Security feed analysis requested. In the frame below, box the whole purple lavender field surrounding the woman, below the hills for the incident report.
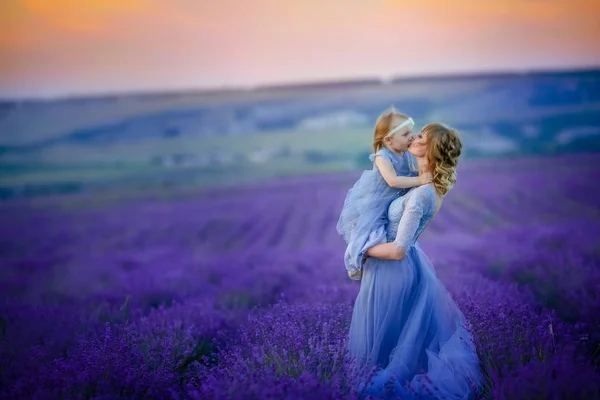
[0,154,600,399]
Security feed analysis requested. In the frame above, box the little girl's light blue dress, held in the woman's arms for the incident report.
[337,147,418,280]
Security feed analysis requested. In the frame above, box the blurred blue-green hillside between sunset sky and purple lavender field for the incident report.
[0,72,600,202]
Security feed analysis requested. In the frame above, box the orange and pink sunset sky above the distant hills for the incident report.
[0,0,600,97]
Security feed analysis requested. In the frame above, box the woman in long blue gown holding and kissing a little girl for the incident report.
[349,124,481,399]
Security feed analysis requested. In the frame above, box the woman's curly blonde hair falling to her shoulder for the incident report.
[421,123,462,196]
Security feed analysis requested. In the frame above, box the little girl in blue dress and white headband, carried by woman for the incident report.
[337,109,432,280]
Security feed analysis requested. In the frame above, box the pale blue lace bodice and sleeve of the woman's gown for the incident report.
[387,185,435,247]
